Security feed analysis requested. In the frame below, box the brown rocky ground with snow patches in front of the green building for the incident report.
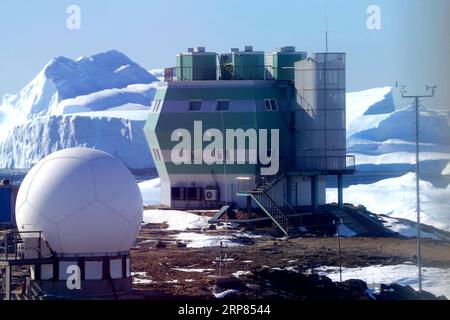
[132,225,450,299]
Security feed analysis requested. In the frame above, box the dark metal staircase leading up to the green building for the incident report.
[240,172,301,236]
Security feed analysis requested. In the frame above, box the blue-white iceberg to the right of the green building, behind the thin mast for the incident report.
[347,87,450,173]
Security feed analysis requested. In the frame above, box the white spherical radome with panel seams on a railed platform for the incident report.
[16,148,143,254]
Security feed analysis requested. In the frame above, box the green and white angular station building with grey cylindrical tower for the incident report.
[145,46,354,234]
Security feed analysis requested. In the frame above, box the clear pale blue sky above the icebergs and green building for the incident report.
[0,0,450,109]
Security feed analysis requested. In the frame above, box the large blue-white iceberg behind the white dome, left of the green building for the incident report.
[0,50,158,169]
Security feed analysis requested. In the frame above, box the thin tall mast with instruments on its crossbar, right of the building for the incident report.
[395,83,437,292]
